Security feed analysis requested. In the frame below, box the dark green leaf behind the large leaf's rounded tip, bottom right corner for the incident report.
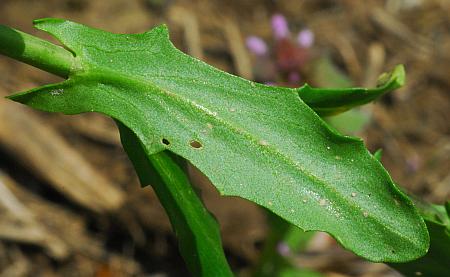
[390,200,450,277]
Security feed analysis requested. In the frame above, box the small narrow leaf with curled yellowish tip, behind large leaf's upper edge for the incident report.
[297,65,405,116]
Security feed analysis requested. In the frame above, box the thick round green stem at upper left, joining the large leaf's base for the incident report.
[0,25,75,78]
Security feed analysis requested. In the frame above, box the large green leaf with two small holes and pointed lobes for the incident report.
[7,19,429,262]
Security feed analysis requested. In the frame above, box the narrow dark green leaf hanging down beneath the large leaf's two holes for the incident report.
[117,122,233,276]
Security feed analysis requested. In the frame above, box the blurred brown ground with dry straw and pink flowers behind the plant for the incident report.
[0,0,450,277]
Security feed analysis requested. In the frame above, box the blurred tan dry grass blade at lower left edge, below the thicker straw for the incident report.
[0,172,105,260]
